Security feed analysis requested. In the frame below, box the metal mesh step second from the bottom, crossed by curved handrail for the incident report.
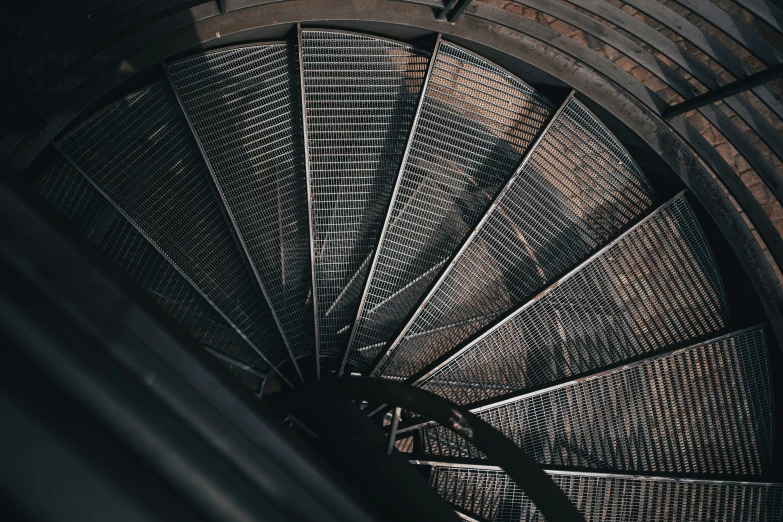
[422,329,772,475]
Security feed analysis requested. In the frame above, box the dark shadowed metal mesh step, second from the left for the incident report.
[60,83,289,365]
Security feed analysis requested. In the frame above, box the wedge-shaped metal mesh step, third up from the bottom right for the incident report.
[420,196,728,404]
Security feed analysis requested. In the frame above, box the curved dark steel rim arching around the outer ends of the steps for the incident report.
[0,0,783,358]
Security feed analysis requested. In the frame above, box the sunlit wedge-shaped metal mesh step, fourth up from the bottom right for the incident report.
[379,99,653,377]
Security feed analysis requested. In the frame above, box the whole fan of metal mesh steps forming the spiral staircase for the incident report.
[4,2,783,521]
